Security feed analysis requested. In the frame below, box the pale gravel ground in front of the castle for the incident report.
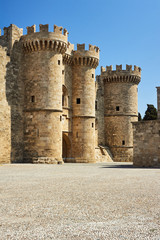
[0,163,160,240]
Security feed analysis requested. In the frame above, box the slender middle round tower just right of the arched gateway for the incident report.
[72,44,99,162]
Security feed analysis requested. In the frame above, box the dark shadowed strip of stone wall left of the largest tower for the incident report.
[6,41,24,162]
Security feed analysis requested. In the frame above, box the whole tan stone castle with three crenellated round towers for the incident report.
[0,24,159,166]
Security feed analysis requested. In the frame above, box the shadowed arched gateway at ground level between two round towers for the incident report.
[62,133,71,162]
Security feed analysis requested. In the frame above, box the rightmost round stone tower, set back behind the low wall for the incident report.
[101,65,141,162]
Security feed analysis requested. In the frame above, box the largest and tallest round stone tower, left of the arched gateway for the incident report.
[21,24,67,163]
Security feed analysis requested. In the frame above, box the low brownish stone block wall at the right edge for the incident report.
[133,120,160,167]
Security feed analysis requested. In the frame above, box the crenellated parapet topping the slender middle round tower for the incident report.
[73,44,99,68]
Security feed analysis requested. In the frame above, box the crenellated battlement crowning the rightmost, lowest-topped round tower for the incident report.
[101,64,141,84]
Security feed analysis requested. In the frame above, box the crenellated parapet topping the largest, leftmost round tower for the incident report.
[21,24,68,53]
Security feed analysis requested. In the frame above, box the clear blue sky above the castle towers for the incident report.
[0,0,160,116]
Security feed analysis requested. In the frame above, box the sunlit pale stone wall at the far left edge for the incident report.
[0,46,11,163]
